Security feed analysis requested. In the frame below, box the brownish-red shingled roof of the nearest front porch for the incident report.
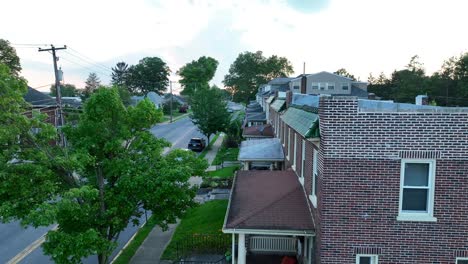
[224,171,315,233]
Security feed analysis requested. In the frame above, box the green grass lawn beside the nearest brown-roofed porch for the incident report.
[161,200,229,260]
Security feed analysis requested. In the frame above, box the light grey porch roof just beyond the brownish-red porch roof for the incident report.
[238,138,284,161]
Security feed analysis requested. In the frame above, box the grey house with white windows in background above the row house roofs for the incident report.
[289,71,368,99]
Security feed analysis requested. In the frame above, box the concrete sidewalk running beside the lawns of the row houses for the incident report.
[130,133,224,264]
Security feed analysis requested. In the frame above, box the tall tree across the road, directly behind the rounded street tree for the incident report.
[177,56,218,97]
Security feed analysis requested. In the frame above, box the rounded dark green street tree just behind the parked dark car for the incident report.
[190,87,230,142]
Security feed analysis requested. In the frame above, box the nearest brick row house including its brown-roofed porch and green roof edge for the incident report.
[223,89,468,264]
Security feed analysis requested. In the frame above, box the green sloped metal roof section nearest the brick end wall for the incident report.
[281,107,320,138]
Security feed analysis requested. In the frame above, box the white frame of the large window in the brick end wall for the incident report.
[397,159,437,222]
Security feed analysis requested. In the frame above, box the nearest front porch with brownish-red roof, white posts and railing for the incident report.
[223,171,315,264]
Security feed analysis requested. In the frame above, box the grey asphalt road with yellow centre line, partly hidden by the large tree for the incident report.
[0,117,203,264]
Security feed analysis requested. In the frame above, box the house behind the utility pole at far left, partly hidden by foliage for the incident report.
[23,87,59,126]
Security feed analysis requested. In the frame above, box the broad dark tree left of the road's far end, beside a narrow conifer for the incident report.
[126,57,171,95]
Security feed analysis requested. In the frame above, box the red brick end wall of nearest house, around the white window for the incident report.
[316,97,468,264]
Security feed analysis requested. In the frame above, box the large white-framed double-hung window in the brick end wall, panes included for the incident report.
[397,159,437,221]
